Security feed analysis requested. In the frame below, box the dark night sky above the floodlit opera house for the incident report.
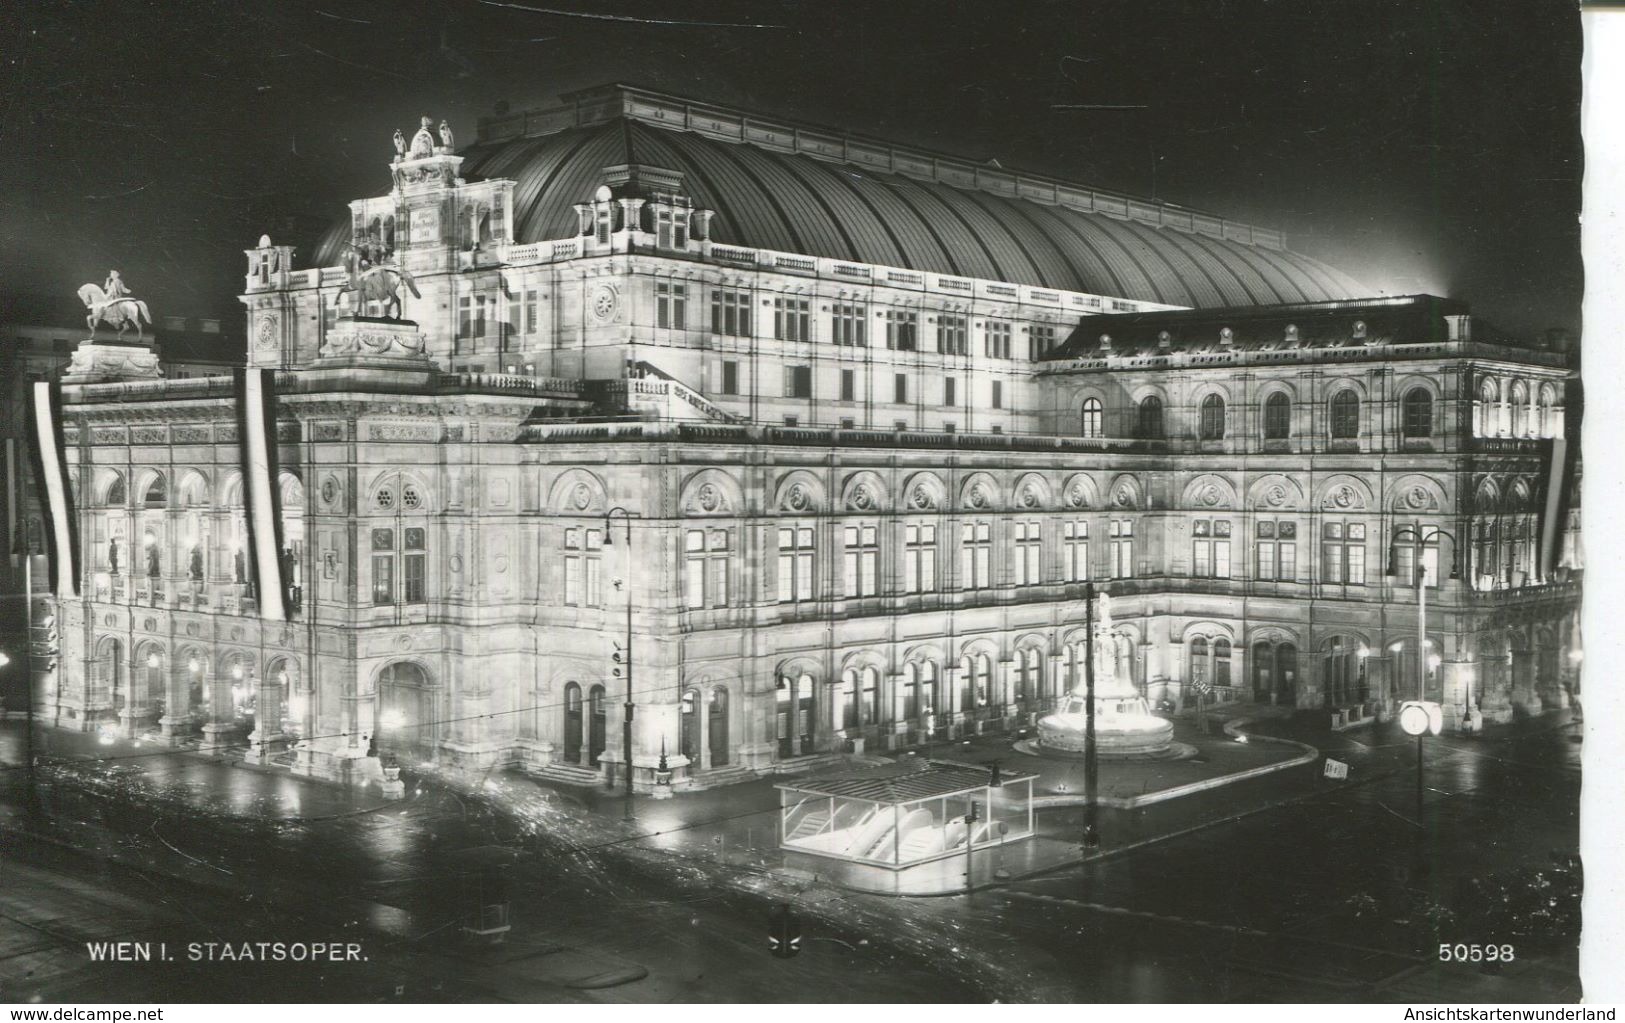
[0,0,1583,333]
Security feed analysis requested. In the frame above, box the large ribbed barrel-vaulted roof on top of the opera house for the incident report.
[313,86,1363,307]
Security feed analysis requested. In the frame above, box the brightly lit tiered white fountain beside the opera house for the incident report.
[1017,594,1188,758]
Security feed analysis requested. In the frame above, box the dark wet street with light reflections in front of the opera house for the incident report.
[0,718,1580,1002]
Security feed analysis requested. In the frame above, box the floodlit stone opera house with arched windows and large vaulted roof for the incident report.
[36,86,1580,788]
